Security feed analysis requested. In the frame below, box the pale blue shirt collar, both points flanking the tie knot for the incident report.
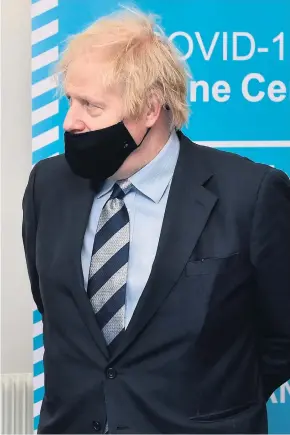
[97,130,180,203]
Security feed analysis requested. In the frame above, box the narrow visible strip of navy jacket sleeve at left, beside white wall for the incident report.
[22,164,44,314]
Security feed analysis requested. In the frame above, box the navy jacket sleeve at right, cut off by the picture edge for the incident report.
[251,169,290,400]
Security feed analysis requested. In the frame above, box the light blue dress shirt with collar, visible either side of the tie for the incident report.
[81,131,180,328]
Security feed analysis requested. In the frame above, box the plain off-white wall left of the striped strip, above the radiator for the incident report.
[0,0,32,373]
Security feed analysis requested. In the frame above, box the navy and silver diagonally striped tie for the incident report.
[87,180,132,353]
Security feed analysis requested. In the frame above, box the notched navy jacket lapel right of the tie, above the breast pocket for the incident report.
[113,133,217,358]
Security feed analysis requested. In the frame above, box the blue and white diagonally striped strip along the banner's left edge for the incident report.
[31,0,62,432]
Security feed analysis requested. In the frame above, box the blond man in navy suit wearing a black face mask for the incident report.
[23,7,290,434]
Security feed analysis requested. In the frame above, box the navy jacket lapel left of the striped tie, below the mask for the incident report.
[63,177,109,359]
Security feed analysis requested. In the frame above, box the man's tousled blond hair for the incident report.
[58,8,189,129]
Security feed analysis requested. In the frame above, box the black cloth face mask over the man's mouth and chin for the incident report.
[64,121,150,182]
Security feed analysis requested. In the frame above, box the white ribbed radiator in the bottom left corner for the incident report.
[1,373,33,434]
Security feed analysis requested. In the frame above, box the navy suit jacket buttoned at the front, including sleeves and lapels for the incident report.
[23,132,290,434]
